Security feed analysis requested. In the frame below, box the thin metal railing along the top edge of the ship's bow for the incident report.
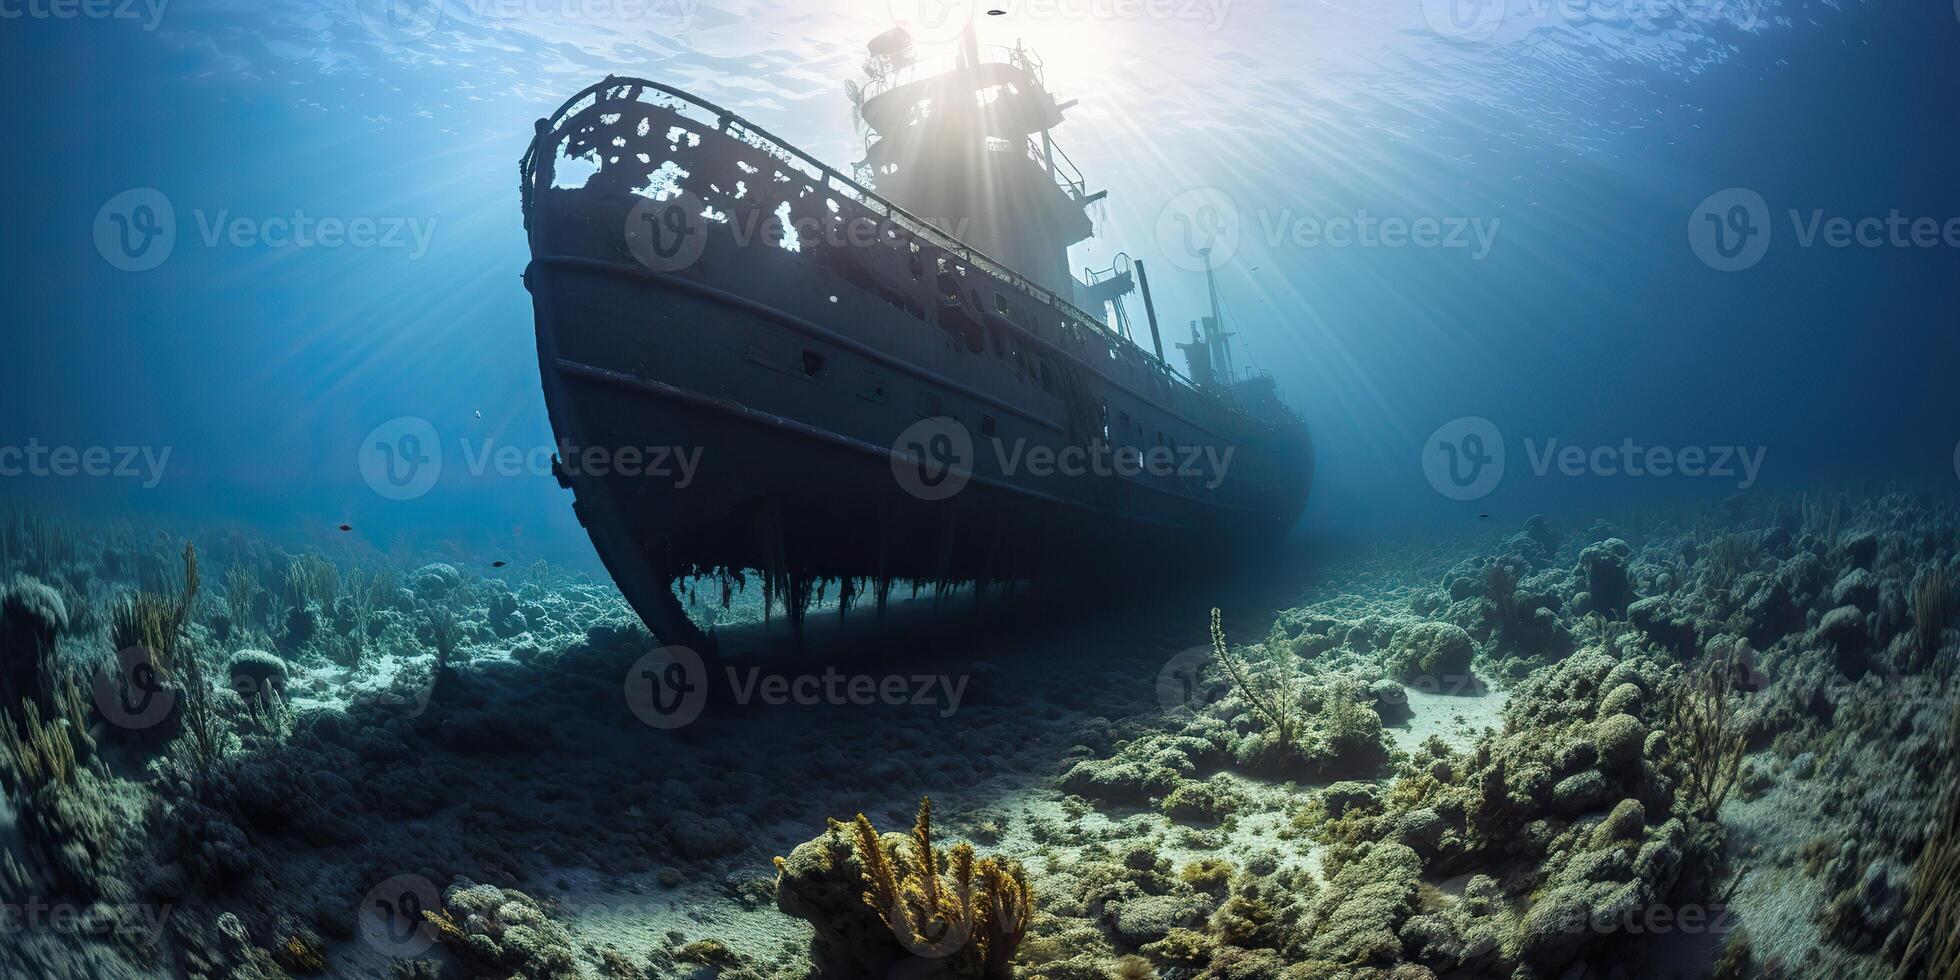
[517,76,1245,421]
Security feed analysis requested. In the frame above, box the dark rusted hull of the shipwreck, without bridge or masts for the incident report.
[525,82,1311,643]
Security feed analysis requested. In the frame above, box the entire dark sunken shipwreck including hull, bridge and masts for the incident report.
[521,29,1313,645]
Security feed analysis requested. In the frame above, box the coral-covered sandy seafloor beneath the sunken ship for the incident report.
[0,494,1960,980]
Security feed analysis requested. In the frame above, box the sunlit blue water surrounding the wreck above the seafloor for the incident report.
[0,0,1960,559]
